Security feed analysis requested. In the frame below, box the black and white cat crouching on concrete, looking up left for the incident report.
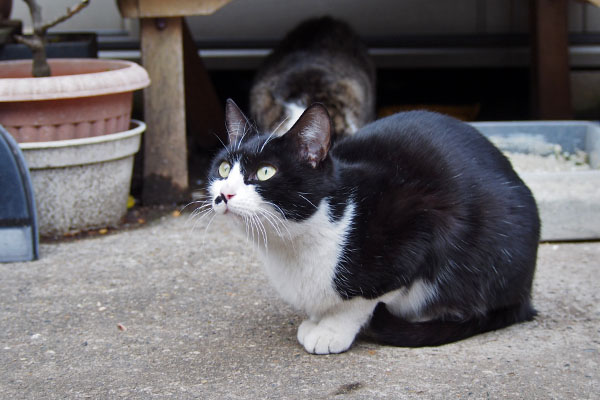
[208,100,540,354]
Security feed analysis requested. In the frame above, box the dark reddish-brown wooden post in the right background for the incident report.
[529,0,573,119]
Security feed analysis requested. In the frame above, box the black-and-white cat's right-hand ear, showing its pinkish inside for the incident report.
[285,103,331,168]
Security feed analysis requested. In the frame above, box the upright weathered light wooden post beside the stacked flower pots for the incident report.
[140,17,188,204]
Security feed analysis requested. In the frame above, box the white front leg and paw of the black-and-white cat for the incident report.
[298,298,377,354]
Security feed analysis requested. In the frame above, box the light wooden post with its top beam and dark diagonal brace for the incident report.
[117,0,237,204]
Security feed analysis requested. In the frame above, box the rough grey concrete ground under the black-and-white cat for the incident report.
[0,214,600,399]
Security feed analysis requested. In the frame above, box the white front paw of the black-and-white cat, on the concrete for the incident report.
[298,320,356,354]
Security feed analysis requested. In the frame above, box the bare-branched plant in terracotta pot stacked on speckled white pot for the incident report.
[0,0,150,235]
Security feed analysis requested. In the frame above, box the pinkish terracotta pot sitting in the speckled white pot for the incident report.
[0,59,150,142]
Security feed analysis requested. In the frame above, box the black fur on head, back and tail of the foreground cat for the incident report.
[207,103,540,346]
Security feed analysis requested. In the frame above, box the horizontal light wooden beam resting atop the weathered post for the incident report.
[117,0,231,18]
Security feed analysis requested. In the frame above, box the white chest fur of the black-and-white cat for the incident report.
[261,201,354,318]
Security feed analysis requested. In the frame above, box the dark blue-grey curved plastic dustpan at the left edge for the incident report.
[0,125,39,262]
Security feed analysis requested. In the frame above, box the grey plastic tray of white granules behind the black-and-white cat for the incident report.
[472,121,600,241]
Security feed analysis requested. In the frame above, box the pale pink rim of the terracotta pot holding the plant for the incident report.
[0,58,150,102]
